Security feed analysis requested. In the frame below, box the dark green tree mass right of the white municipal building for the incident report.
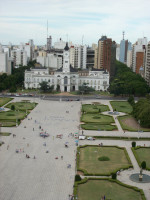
[109,61,150,96]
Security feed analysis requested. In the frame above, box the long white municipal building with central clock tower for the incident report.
[24,43,109,92]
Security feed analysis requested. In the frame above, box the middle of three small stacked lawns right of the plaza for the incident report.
[81,113,114,124]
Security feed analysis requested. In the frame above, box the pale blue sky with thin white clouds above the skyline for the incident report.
[0,0,150,46]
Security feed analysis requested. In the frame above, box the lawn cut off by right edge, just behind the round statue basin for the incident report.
[134,147,150,170]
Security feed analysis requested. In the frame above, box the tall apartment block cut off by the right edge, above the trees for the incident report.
[145,42,150,86]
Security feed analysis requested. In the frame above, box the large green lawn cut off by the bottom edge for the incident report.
[77,180,142,200]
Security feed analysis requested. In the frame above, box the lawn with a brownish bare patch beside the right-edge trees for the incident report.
[118,115,150,132]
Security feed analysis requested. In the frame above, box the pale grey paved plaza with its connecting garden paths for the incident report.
[0,98,150,200]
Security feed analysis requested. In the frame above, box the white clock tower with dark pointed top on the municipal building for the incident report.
[63,42,70,73]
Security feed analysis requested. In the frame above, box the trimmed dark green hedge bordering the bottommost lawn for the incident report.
[73,177,146,200]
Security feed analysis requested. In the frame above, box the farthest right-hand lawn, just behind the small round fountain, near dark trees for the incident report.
[110,101,133,114]
